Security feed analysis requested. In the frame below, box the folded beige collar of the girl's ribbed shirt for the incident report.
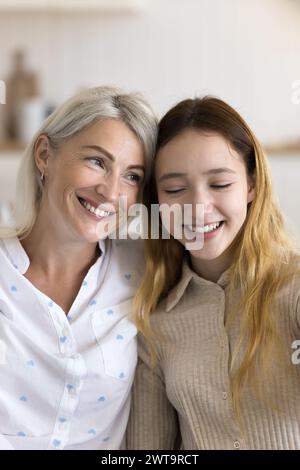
[166,258,230,312]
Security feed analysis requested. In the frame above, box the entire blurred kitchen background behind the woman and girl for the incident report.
[0,0,300,237]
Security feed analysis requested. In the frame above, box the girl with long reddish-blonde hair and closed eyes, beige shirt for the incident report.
[127,97,300,449]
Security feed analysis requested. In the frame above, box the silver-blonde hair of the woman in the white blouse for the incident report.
[0,86,157,238]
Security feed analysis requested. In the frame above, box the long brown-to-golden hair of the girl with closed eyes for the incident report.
[134,97,296,414]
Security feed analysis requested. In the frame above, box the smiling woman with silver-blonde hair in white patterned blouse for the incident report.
[0,87,156,449]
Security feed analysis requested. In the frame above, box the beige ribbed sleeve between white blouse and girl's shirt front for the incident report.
[126,335,178,450]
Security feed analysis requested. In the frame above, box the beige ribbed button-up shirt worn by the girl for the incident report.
[127,263,300,450]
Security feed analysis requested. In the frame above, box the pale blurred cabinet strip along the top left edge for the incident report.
[0,0,145,12]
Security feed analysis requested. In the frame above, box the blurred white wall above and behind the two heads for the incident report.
[0,0,300,142]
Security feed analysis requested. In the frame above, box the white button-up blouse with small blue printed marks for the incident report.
[0,238,144,450]
